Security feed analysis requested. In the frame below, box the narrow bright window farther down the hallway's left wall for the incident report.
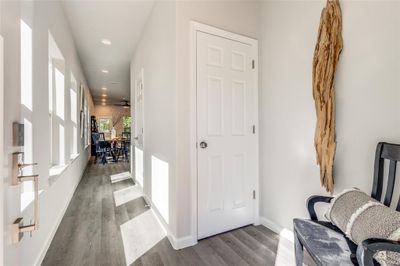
[70,73,78,159]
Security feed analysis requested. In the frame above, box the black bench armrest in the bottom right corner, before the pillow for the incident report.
[357,238,400,266]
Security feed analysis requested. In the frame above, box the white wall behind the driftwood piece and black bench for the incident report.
[260,1,400,229]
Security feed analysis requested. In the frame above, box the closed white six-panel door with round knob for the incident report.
[196,31,258,239]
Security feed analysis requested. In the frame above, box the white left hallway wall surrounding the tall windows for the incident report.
[0,1,93,265]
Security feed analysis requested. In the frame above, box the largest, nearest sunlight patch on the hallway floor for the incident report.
[121,211,166,265]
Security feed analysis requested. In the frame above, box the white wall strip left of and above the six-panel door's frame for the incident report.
[176,1,259,238]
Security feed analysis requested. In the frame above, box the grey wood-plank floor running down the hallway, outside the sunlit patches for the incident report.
[42,160,288,266]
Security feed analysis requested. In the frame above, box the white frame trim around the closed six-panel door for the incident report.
[190,21,260,244]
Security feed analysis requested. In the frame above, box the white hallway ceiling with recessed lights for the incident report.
[63,0,154,104]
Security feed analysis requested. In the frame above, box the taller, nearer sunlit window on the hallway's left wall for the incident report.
[48,32,66,166]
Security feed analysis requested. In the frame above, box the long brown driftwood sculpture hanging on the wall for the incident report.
[313,0,343,192]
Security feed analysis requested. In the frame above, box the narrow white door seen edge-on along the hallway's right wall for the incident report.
[134,69,144,187]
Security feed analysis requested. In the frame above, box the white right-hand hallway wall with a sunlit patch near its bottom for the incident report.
[131,2,177,239]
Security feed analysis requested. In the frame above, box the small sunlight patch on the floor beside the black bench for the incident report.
[275,228,296,266]
